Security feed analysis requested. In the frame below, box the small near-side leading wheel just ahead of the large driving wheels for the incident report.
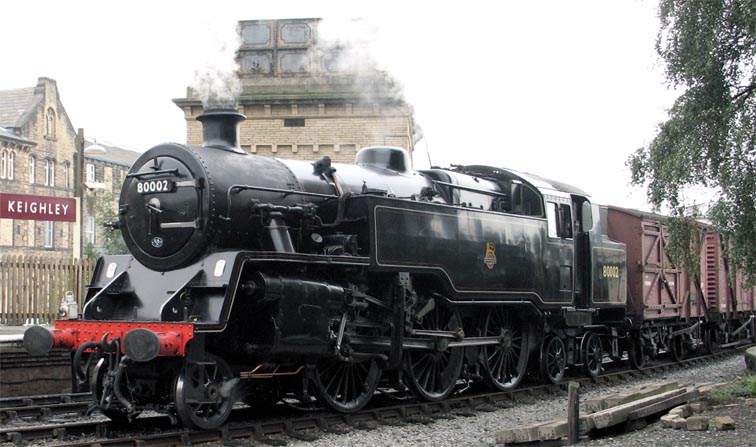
[175,354,234,430]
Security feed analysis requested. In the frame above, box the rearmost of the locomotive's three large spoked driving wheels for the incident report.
[482,307,528,391]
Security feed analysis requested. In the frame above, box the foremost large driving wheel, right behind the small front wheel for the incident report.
[313,358,381,413]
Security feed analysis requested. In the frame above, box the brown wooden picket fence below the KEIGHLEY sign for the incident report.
[0,255,97,325]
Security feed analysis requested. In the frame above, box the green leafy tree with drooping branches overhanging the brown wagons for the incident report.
[628,0,756,282]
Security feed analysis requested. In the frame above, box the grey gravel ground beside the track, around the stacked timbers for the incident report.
[287,354,756,447]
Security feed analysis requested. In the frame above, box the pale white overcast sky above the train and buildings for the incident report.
[0,0,675,208]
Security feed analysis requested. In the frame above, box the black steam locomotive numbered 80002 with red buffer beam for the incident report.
[25,111,752,428]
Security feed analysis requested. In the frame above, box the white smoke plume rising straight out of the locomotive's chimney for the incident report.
[189,23,241,110]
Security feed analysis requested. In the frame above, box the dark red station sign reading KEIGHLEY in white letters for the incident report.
[0,192,76,222]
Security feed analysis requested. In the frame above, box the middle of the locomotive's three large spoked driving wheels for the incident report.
[403,306,464,401]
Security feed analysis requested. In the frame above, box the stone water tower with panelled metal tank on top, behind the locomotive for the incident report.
[174,19,415,163]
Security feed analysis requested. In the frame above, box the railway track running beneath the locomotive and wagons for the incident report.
[0,347,745,447]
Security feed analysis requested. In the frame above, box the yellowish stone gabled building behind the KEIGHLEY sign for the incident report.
[0,77,139,256]
